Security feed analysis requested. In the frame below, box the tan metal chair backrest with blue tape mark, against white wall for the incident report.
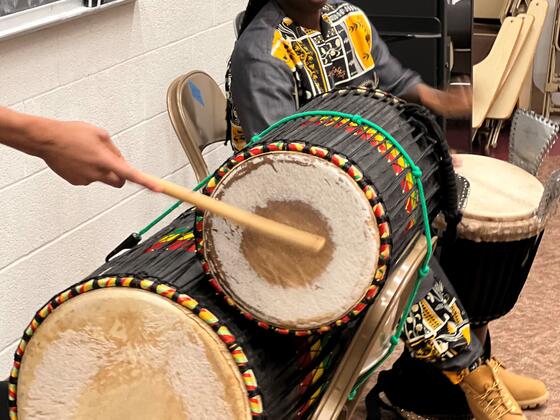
[167,71,227,181]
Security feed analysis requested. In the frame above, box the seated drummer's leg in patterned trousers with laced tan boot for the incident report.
[403,261,524,420]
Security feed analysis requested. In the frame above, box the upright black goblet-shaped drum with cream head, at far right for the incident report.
[441,155,546,325]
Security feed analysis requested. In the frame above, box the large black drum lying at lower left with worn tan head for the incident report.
[9,210,352,420]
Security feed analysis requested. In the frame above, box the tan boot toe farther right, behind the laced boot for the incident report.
[488,358,548,409]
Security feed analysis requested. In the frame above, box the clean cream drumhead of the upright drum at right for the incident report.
[455,155,544,221]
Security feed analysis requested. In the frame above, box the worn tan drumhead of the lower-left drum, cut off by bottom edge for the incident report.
[17,288,251,420]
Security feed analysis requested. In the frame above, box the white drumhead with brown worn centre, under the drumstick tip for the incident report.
[204,152,379,329]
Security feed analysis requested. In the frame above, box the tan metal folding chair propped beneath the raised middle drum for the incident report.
[311,236,436,420]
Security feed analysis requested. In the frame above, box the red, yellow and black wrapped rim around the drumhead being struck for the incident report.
[195,139,393,336]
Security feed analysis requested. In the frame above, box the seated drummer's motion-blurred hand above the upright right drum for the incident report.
[416,83,472,119]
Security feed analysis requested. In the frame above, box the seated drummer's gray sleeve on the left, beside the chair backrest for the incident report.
[231,48,296,140]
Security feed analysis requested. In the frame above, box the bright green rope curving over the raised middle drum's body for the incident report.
[249,111,433,401]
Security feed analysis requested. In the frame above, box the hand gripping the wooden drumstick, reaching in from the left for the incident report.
[28,117,160,191]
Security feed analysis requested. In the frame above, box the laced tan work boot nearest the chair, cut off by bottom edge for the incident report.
[460,362,525,420]
